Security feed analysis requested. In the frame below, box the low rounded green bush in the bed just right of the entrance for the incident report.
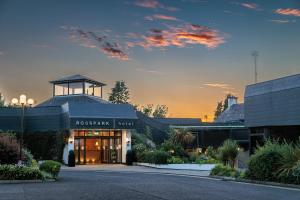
[141,150,170,164]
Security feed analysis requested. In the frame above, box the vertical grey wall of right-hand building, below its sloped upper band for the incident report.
[245,86,300,127]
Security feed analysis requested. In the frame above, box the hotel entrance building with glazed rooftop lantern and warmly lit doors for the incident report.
[0,75,137,164]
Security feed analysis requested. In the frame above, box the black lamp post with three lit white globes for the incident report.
[11,94,34,164]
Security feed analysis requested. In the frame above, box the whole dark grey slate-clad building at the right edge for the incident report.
[244,74,300,151]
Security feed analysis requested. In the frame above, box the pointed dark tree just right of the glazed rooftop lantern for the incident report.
[108,81,129,104]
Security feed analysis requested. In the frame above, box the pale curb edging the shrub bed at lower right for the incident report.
[209,176,300,189]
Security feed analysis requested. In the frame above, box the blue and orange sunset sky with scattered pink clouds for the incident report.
[0,0,300,120]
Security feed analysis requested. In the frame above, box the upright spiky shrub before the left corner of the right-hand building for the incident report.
[218,139,238,168]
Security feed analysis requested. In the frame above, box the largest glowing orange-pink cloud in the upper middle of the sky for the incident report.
[131,24,225,49]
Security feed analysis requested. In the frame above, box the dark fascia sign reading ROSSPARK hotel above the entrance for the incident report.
[70,118,136,129]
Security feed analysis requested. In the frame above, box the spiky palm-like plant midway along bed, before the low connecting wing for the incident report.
[171,129,195,146]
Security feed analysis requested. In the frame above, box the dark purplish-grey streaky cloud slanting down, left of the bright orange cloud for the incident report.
[61,26,129,60]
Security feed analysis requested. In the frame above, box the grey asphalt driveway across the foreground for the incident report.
[0,166,300,200]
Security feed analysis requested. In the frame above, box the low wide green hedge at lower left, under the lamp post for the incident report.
[0,165,43,180]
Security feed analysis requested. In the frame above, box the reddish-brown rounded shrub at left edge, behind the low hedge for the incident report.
[0,133,20,164]
